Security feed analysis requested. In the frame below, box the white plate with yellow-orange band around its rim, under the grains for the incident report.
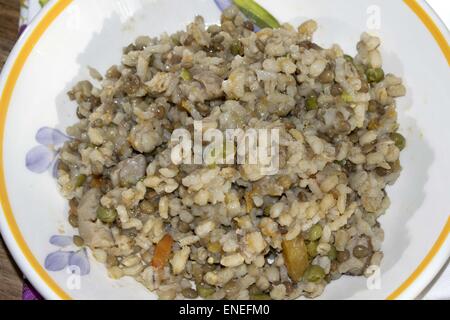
[0,0,450,299]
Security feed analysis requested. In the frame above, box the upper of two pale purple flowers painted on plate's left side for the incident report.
[25,127,70,175]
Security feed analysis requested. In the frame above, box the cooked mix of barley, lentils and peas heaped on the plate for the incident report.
[58,7,405,299]
